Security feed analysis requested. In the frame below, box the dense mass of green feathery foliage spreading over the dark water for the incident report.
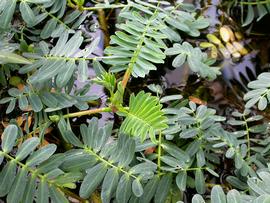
[0,0,270,203]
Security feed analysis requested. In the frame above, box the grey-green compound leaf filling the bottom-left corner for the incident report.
[0,125,81,203]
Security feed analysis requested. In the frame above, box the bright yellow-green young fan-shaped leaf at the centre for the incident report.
[120,91,167,142]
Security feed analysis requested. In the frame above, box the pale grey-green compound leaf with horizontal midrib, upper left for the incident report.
[20,32,99,88]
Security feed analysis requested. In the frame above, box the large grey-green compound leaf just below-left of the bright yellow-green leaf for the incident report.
[61,118,156,202]
